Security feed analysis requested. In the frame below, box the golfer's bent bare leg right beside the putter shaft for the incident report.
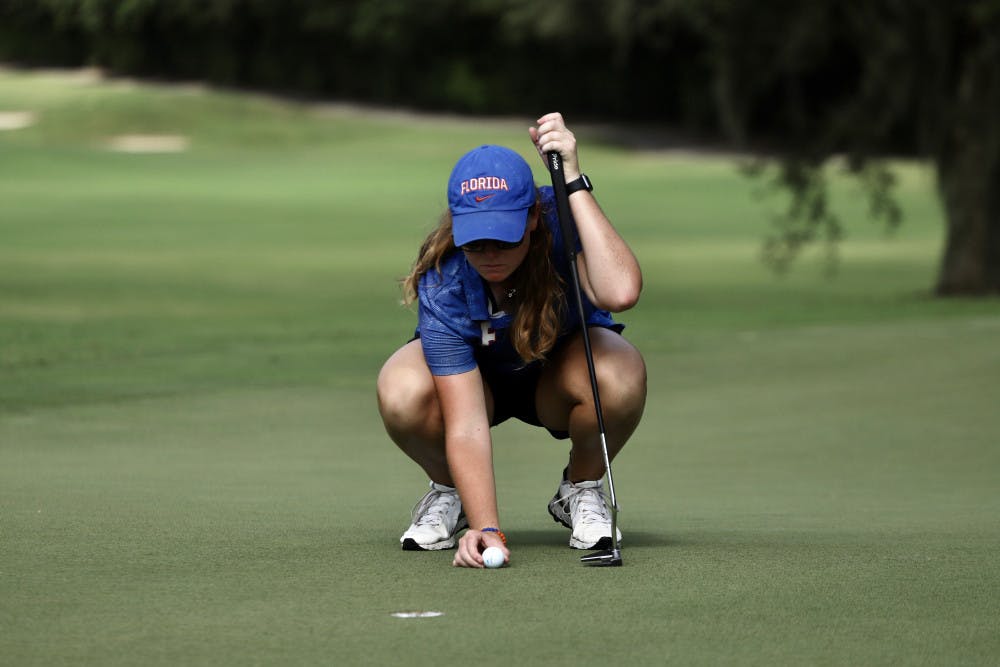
[535,327,646,482]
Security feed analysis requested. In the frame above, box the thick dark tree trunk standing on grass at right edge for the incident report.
[937,28,1000,296]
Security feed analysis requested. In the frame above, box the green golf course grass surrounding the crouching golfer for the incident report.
[0,70,1000,666]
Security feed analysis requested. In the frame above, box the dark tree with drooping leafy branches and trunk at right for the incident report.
[692,0,1000,295]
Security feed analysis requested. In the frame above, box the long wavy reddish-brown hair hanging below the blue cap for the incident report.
[401,198,566,362]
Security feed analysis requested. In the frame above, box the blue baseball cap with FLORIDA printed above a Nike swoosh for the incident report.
[448,146,535,246]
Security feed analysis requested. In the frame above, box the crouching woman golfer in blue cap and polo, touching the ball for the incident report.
[378,113,646,567]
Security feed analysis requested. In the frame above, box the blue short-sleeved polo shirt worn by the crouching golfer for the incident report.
[416,187,624,375]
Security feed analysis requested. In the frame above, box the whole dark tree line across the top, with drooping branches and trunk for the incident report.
[0,0,1000,294]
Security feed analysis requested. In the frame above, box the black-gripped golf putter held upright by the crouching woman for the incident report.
[545,151,622,566]
